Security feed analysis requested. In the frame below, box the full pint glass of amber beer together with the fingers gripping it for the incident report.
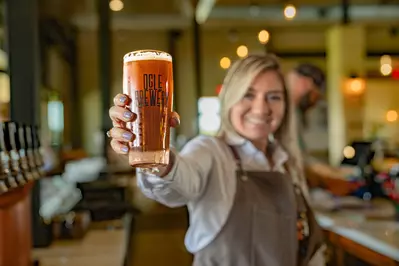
[110,50,179,168]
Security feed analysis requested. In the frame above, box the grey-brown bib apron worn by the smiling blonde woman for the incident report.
[193,147,321,266]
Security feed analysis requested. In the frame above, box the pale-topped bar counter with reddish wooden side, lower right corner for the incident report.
[316,206,399,266]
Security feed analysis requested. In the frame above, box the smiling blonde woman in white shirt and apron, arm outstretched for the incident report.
[109,55,322,266]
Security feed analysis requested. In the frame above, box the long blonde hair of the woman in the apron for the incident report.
[218,54,304,185]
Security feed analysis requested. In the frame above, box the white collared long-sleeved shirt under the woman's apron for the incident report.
[137,136,288,253]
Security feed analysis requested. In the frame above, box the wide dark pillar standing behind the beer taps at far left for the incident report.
[5,0,48,249]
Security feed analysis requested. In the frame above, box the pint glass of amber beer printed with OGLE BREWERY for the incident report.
[123,50,173,168]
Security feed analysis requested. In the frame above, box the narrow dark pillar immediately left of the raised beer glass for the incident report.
[97,0,112,158]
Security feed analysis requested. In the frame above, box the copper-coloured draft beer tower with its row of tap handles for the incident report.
[0,121,43,266]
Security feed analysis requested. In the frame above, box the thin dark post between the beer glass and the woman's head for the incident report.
[193,18,202,135]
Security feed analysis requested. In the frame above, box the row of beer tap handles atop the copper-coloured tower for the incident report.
[0,122,43,195]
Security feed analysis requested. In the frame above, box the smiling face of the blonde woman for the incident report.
[230,70,286,146]
